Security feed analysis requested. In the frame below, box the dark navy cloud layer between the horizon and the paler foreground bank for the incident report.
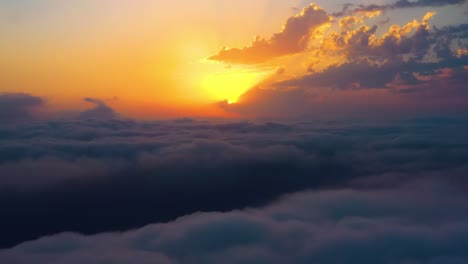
[0,114,468,250]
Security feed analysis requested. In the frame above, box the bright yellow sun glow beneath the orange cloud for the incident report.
[202,69,270,104]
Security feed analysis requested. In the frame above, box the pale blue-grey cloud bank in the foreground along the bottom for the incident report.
[0,181,468,264]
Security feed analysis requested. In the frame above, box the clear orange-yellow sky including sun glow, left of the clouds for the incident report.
[0,0,298,117]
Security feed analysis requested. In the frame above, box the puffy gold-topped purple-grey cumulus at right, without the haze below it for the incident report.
[272,12,468,96]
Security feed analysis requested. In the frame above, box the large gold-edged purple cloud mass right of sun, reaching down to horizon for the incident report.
[221,12,468,118]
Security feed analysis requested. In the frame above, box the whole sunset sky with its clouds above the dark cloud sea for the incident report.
[0,0,467,119]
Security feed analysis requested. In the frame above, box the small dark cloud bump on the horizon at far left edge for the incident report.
[0,93,45,123]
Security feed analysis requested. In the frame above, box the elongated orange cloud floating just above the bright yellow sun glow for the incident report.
[209,4,330,64]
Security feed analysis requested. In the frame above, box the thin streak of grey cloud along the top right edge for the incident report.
[333,0,466,17]
